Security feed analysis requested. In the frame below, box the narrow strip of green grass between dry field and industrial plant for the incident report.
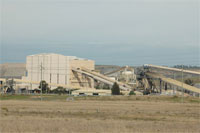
[0,94,200,103]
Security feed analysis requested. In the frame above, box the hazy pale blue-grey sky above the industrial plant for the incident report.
[0,0,200,66]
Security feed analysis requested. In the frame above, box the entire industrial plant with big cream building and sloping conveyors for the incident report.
[0,53,200,96]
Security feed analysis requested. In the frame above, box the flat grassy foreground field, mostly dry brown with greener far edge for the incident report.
[0,96,200,133]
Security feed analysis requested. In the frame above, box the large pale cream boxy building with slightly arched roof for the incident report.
[23,53,95,89]
